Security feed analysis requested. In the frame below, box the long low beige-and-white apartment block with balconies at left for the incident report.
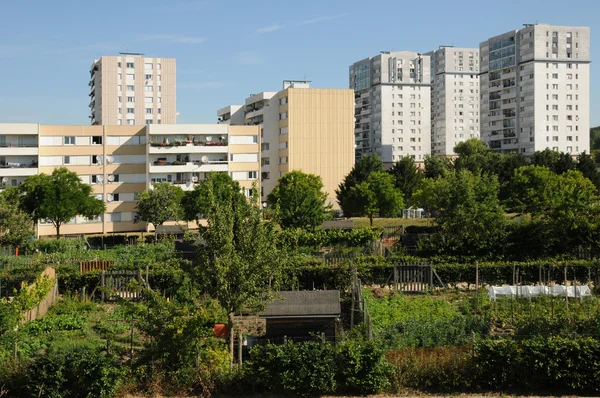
[0,123,260,236]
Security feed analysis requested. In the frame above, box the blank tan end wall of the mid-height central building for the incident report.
[279,88,354,206]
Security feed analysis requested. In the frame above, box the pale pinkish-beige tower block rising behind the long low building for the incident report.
[89,53,177,125]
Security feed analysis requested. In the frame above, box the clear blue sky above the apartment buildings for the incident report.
[0,0,600,126]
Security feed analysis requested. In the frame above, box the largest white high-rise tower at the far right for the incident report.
[479,24,590,156]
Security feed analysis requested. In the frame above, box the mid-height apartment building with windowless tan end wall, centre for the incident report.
[217,81,354,208]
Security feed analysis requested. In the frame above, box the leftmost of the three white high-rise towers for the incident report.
[349,51,431,166]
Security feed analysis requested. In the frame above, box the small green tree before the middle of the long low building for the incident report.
[136,182,183,236]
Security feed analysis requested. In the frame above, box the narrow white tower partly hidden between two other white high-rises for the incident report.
[426,46,480,156]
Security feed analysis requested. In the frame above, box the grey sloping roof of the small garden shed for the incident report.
[260,290,342,318]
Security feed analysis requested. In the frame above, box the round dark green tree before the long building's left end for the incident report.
[20,167,106,238]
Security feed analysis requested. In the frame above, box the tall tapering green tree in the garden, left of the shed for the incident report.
[194,175,285,364]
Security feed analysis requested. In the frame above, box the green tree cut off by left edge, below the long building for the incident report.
[0,192,33,247]
